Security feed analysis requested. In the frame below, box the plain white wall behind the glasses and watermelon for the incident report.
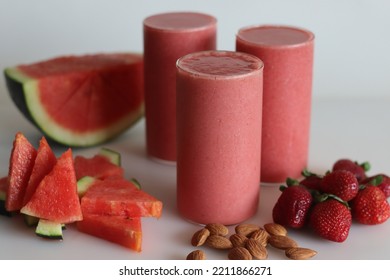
[0,0,390,100]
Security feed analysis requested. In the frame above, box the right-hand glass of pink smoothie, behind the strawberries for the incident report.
[236,25,314,183]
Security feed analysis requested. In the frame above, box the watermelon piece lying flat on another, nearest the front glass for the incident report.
[81,178,162,218]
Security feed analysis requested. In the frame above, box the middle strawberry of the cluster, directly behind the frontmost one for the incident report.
[322,170,359,201]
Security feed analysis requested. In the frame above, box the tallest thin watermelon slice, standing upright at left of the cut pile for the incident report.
[5,132,37,212]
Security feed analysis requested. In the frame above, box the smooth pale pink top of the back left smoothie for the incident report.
[144,12,216,31]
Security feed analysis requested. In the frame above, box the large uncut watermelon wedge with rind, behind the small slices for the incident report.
[4,53,144,147]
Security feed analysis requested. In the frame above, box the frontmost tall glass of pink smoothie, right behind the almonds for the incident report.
[177,51,263,225]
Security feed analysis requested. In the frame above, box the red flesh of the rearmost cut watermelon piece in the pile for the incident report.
[74,155,124,180]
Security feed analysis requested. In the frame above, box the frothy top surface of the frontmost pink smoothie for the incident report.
[177,51,263,77]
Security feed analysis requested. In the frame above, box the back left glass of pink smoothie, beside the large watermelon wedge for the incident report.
[143,12,217,163]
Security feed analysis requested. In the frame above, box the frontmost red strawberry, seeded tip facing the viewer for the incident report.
[310,198,352,242]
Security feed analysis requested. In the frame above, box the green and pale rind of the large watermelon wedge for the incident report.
[4,67,144,147]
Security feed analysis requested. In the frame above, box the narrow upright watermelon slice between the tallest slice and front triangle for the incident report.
[23,137,57,205]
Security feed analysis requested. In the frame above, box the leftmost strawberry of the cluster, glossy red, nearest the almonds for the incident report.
[272,185,313,228]
